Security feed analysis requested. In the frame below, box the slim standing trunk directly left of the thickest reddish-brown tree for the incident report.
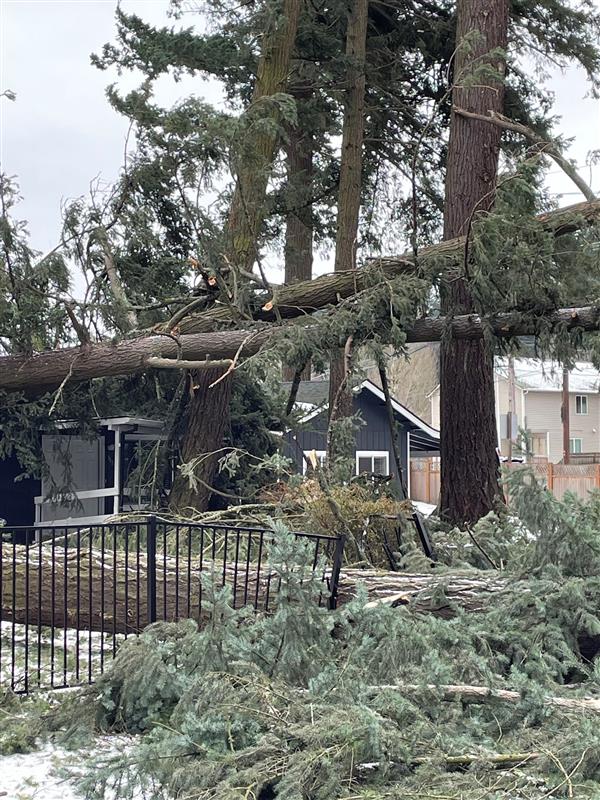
[329,0,369,457]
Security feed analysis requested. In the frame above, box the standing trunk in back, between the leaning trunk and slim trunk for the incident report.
[283,87,313,381]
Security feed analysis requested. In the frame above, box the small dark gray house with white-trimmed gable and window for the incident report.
[284,380,440,496]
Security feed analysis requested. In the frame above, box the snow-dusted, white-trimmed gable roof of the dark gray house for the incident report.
[284,380,440,450]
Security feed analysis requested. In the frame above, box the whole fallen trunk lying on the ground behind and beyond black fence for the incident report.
[0,534,510,633]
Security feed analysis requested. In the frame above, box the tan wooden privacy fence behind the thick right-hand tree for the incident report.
[410,459,600,504]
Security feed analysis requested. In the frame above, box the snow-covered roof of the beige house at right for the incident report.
[495,358,600,394]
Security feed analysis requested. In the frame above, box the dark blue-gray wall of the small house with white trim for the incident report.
[284,392,408,484]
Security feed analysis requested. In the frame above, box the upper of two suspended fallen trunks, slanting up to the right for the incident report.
[179,201,600,332]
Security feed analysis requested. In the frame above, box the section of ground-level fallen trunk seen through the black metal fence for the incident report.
[0,539,286,634]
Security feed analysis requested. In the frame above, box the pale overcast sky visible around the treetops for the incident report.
[0,0,600,270]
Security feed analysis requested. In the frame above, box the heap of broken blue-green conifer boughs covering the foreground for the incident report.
[48,494,600,800]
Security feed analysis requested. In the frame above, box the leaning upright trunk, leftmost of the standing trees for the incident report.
[170,0,302,511]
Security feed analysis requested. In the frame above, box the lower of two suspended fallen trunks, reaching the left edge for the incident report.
[0,306,600,392]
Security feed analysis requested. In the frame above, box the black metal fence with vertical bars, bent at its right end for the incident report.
[0,516,343,693]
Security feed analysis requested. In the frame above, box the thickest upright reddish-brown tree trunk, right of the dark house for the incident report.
[440,0,508,524]
